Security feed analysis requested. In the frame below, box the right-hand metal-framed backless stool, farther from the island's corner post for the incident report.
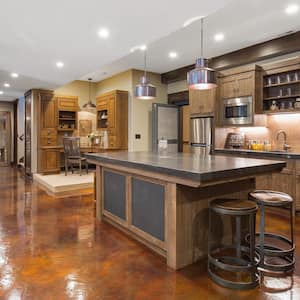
[249,190,295,275]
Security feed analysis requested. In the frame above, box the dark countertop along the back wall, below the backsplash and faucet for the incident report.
[214,148,300,159]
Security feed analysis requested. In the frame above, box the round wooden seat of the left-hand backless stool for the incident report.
[210,199,258,215]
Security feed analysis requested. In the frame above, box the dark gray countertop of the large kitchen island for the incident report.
[85,151,286,184]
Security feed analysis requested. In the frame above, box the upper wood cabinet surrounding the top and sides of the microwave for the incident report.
[218,65,262,113]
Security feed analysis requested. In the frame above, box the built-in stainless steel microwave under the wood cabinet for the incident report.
[222,96,253,125]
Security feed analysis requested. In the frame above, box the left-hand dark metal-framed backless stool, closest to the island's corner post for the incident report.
[208,199,259,290]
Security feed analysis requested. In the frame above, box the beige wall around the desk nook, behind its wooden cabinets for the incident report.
[55,70,168,151]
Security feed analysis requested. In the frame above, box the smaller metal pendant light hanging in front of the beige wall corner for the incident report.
[135,50,156,100]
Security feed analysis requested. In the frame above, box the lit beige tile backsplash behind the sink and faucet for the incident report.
[215,114,300,152]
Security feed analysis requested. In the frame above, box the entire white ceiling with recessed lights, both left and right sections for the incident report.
[0,0,300,101]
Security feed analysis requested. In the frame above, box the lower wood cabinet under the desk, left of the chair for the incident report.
[40,149,60,174]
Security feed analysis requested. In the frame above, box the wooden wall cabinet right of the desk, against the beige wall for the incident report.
[96,90,128,149]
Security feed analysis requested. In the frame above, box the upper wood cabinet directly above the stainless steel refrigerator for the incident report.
[189,89,217,115]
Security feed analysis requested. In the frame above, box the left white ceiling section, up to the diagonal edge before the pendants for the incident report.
[0,0,230,100]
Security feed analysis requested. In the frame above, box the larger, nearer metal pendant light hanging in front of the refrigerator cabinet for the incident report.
[187,18,217,90]
